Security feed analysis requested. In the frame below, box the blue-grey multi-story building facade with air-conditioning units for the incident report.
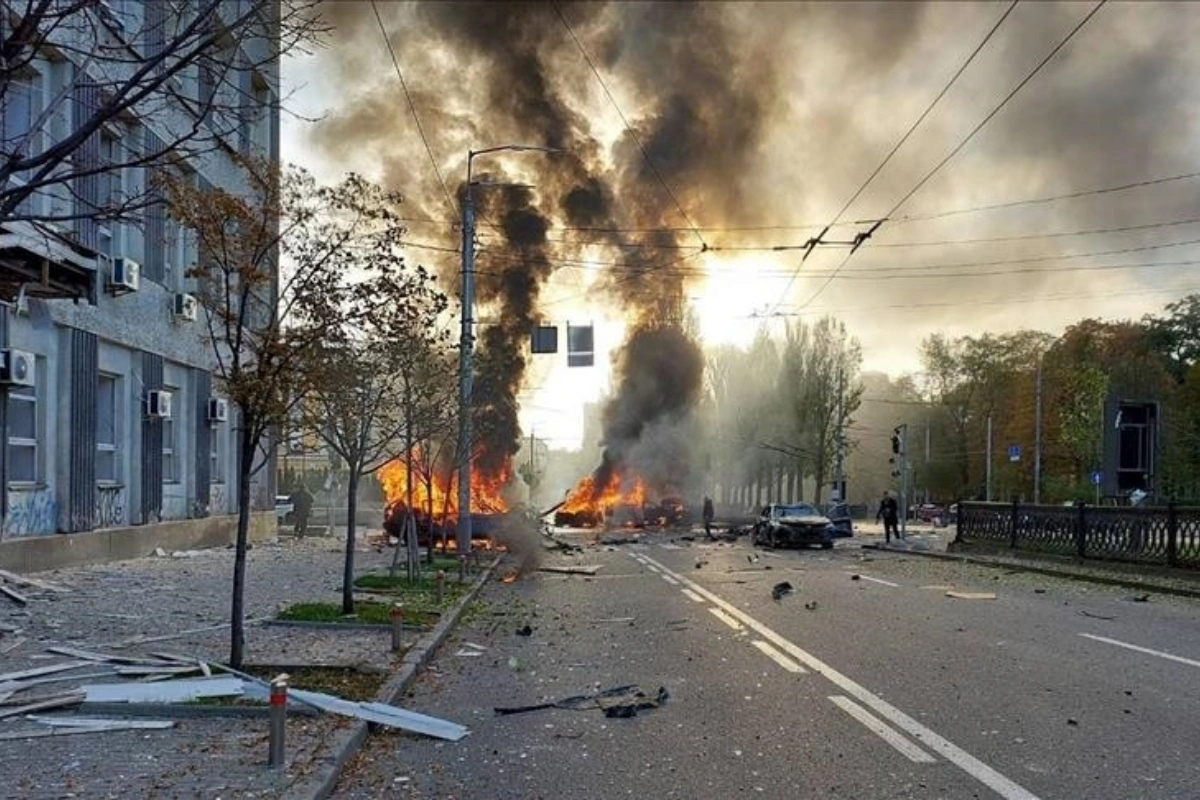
[0,0,280,570]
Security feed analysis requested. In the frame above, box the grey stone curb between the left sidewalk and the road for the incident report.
[287,557,503,800]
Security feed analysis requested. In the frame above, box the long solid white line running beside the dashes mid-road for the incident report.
[646,558,1037,800]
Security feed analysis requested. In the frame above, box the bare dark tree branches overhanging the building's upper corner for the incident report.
[0,0,326,233]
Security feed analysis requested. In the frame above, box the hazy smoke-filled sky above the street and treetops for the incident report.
[283,1,1200,445]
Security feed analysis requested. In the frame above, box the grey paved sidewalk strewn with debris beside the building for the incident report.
[0,537,487,799]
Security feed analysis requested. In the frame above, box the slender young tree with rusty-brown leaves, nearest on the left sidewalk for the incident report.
[162,162,403,666]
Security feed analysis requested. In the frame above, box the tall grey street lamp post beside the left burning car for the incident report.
[457,144,562,553]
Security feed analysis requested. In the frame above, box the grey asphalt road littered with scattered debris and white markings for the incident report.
[336,527,1200,799]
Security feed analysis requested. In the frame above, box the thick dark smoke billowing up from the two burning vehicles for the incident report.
[309,2,774,492]
